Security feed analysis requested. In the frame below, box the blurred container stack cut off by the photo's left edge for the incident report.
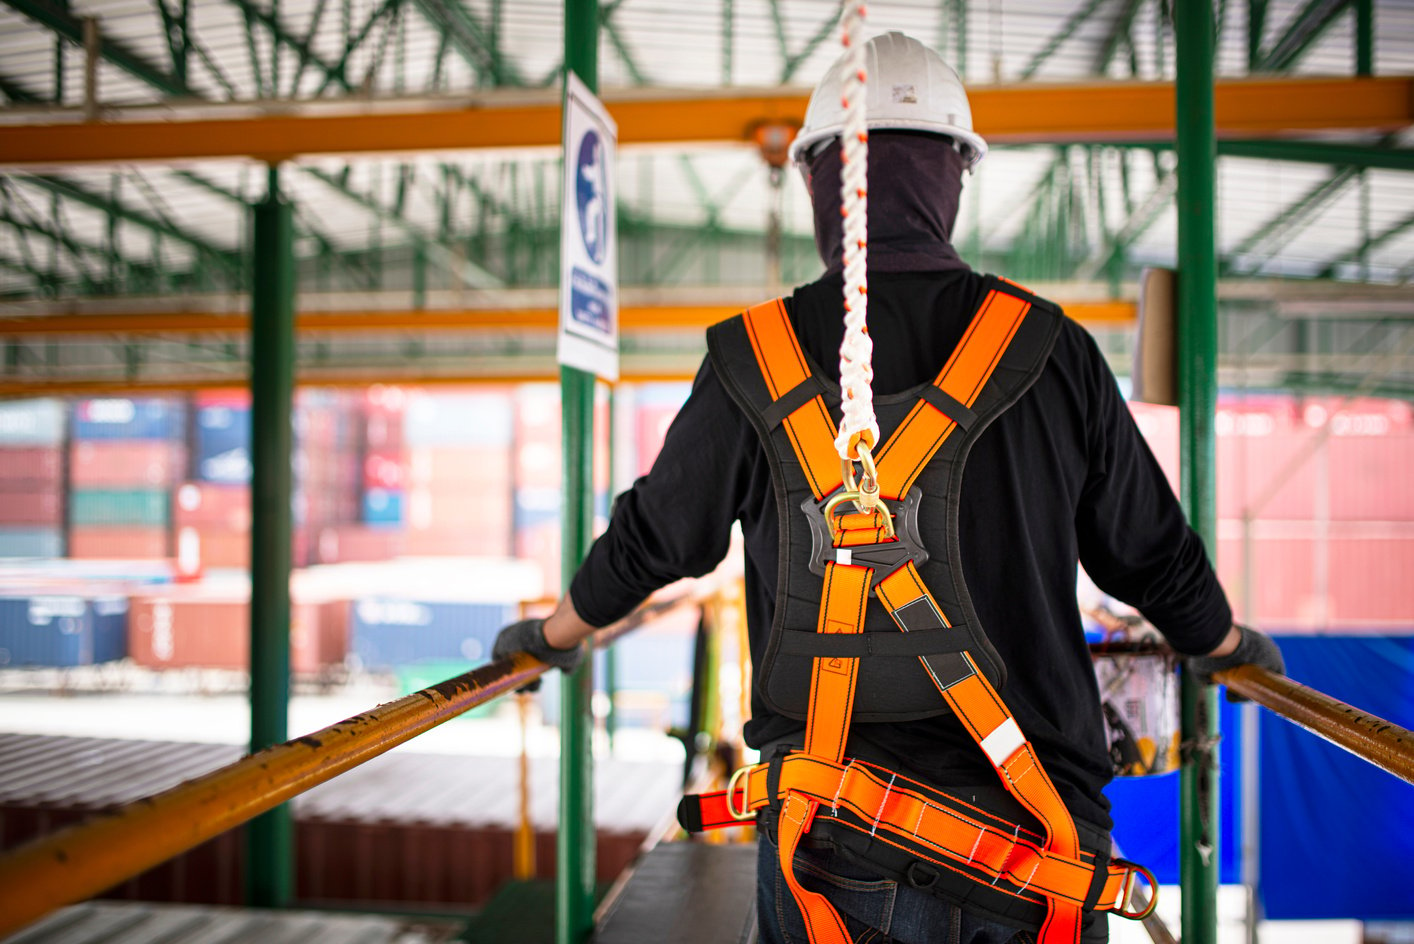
[0,400,64,557]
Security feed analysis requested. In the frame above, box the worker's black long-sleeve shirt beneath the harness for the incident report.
[570,271,1232,827]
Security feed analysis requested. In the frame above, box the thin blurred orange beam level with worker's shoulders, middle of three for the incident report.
[0,301,1135,336]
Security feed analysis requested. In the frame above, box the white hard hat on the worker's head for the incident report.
[790,33,987,170]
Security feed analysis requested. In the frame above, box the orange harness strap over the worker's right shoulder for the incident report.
[874,290,1031,499]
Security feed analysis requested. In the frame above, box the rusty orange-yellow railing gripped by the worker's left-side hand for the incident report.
[0,596,690,938]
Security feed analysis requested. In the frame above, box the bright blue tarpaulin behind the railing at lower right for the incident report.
[1106,636,1414,921]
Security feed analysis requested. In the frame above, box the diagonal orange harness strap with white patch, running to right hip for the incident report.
[877,561,1082,944]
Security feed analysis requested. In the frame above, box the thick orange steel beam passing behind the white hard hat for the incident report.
[0,76,1414,167]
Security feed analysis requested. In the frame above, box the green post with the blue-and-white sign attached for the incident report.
[554,0,600,944]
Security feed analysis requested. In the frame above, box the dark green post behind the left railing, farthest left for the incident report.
[246,167,294,907]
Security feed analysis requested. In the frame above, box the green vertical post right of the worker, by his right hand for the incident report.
[1174,0,1219,944]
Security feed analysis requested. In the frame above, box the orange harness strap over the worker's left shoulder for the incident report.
[742,298,843,500]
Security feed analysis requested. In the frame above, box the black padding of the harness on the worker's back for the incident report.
[707,277,1062,724]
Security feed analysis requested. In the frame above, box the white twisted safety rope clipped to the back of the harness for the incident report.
[834,0,880,462]
